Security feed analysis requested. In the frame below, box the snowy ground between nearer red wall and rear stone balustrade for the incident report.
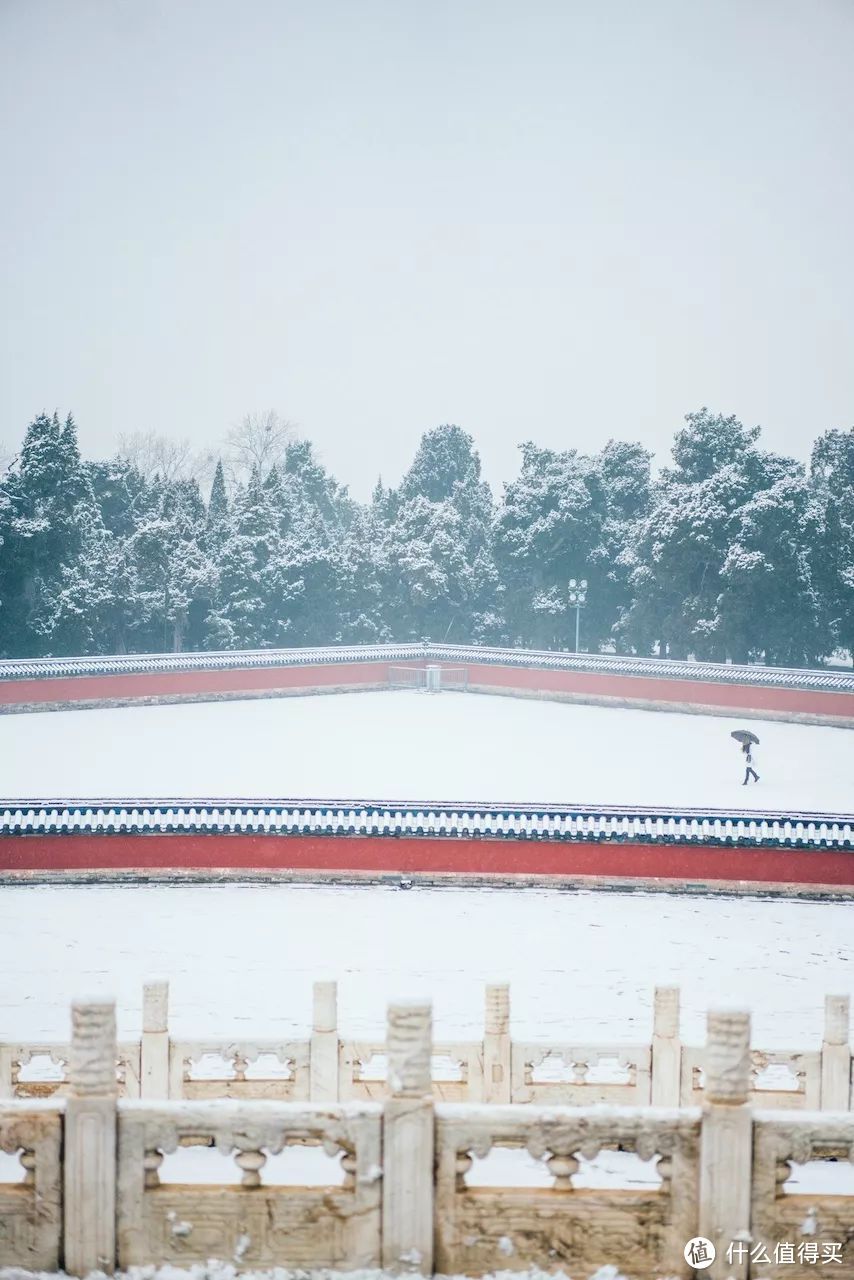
[0,884,854,1048]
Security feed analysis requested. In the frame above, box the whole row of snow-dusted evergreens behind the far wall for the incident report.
[0,408,854,664]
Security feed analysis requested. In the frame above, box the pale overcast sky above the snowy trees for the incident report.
[0,0,854,497]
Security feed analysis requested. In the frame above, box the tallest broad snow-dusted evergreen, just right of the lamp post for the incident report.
[620,408,827,663]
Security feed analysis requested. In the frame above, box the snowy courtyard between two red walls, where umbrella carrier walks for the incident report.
[0,691,854,813]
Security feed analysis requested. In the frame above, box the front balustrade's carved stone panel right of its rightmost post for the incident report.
[752,1111,854,1280]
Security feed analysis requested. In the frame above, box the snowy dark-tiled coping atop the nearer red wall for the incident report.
[0,799,854,849]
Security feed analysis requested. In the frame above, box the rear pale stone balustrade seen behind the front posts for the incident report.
[0,982,854,1111]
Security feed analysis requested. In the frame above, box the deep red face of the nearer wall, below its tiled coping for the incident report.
[0,835,854,888]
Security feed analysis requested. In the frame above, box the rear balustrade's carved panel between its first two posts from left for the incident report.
[169,1039,310,1102]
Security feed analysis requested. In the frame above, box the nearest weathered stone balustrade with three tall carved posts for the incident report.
[0,1000,854,1280]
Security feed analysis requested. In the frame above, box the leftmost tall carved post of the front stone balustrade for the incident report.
[64,1000,118,1276]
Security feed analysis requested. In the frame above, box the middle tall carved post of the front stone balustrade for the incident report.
[383,1004,434,1276]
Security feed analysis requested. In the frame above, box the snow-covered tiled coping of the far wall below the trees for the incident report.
[0,644,854,692]
